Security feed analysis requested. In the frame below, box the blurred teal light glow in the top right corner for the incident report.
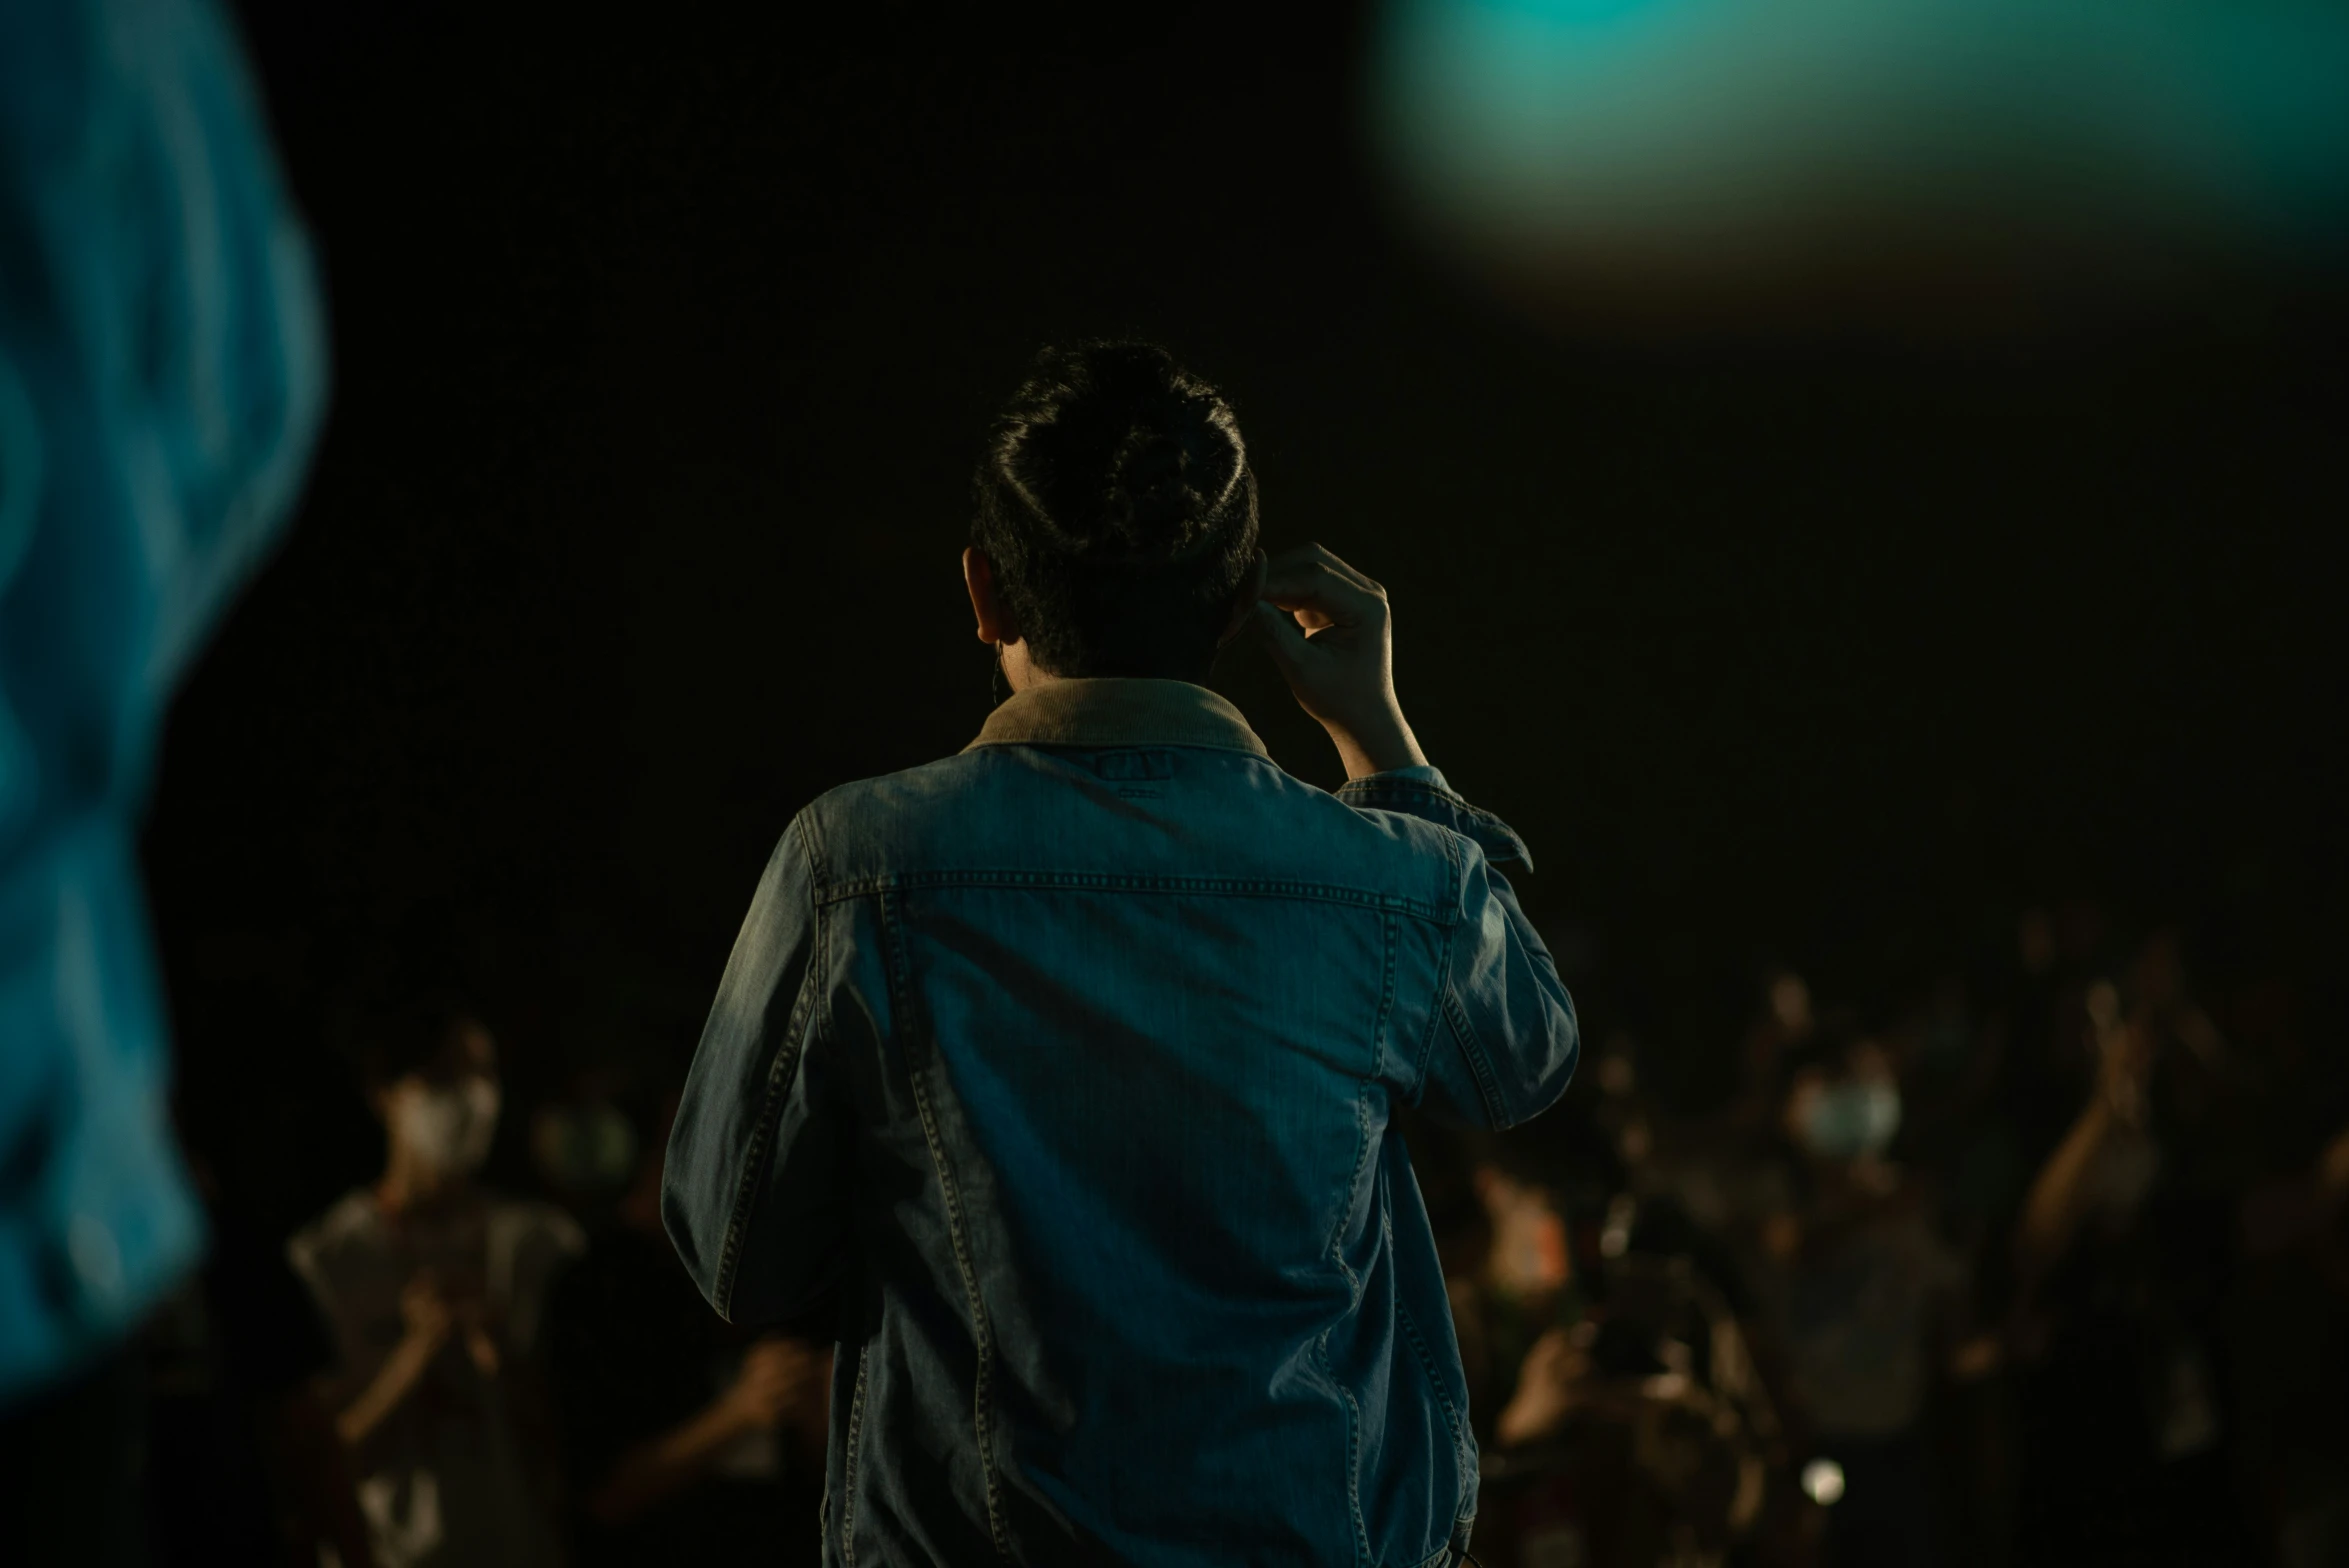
[1379,0,2349,261]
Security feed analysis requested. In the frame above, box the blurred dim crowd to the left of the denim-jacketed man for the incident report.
[141,993,832,1568]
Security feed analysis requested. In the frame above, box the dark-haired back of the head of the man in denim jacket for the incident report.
[970,343,1257,678]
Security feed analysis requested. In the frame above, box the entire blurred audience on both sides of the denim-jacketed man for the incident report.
[128,906,2349,1568]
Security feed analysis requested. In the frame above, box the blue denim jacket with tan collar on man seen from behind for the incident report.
[662,681,1576,1568]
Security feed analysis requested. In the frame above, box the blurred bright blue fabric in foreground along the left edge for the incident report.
[0,0,324,1404]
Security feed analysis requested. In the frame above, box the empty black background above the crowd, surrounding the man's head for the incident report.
[148,0,2349,1218]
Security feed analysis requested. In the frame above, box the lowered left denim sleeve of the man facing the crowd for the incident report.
[660,812,855,1324]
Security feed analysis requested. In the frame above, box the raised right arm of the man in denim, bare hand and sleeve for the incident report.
[1257,545,1579,1129]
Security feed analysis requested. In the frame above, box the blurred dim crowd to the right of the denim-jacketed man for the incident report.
[1414,904,2349,1568]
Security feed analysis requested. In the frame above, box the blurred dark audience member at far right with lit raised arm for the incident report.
[2013,932,2255,1563]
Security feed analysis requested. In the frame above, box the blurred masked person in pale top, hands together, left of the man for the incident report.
[287,1000,583,1568]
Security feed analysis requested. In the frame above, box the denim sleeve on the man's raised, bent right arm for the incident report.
[1339,768,1581,1131]
